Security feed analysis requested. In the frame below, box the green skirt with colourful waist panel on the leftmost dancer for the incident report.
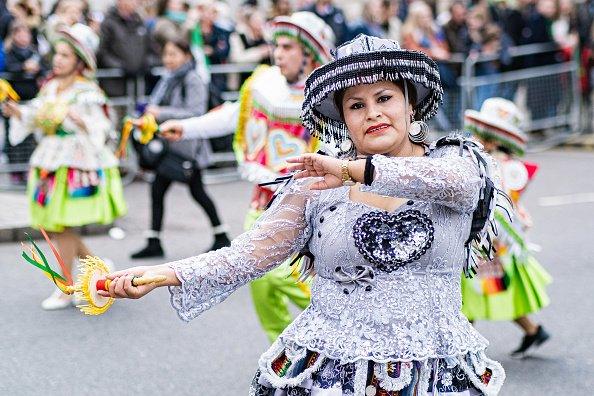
[27,167,127,232]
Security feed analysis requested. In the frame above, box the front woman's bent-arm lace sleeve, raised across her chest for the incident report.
[361,146,483,212]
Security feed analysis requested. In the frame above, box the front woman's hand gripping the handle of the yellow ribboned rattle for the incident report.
[97,265,180,299]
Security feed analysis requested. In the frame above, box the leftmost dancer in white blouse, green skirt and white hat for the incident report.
[2,24,126,310]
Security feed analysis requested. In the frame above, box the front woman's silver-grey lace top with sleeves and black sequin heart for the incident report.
[170,146,487,362]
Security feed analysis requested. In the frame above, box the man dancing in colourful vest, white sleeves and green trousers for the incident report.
[160,12,334,342]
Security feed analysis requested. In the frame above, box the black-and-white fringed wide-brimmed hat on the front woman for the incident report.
[301,34,443,155]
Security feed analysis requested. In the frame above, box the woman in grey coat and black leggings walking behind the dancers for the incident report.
[132,37,230,259]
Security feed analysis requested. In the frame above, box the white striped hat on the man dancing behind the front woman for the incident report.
[267,11,335,65]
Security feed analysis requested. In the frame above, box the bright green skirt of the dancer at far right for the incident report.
[462,255,552,321]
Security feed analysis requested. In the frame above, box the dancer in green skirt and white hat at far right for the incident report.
[462,98,551,358]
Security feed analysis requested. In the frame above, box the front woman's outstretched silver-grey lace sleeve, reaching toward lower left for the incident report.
[169,179,318,321]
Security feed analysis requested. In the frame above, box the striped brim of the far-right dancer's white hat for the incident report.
[464,110,528,155]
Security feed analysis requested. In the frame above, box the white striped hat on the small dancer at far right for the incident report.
[464,98,528,156]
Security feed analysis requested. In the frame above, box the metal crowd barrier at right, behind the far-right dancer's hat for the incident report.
[459,43,584,150]
